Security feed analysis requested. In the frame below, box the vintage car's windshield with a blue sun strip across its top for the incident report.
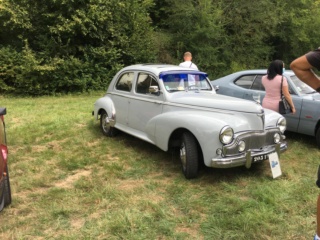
[160,72,212,92]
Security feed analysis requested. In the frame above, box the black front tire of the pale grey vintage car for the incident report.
[180,132,199,179]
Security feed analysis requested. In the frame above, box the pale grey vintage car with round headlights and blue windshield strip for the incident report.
[92,64,287,179]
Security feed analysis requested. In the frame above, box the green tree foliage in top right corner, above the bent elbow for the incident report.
[270,0,320,64]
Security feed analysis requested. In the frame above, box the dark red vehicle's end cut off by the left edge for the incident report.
[0,108,11,211]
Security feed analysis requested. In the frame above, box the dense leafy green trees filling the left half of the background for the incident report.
[0,0,155,94]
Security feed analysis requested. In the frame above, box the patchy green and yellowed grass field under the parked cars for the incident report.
[0,93,320,240]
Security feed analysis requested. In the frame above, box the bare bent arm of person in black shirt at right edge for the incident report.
[290,56,320,92]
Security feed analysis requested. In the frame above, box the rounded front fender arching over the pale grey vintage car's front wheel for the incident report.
[146,111,263,151]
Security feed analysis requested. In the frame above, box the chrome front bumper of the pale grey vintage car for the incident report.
[211,142,288,168]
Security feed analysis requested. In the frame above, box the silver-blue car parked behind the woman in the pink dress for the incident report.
[211,69,320,148]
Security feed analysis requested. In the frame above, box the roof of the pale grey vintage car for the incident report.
[122,63,203,75]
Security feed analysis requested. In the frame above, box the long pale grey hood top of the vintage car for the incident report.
[170,92,263,113]
